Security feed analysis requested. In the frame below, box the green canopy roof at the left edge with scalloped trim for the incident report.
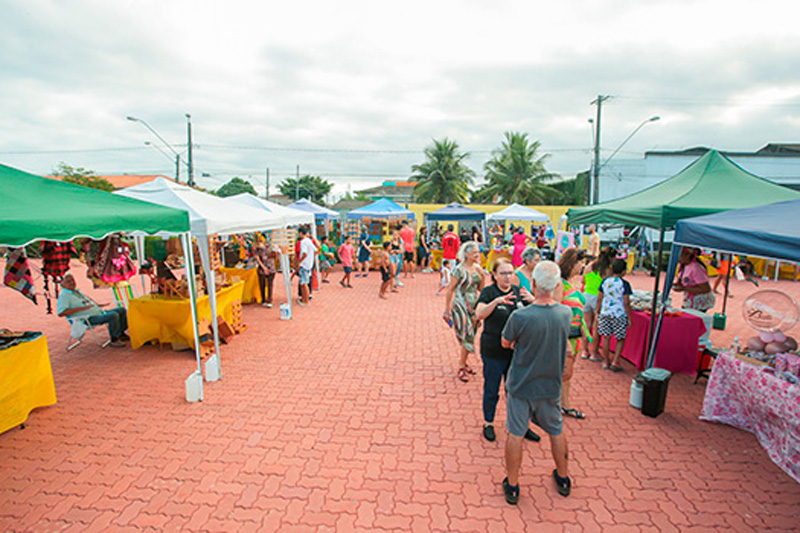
[0,164,189,246]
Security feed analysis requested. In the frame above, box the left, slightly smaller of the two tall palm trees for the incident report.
[411,137,475,204]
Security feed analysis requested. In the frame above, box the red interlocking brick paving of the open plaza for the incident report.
[0,260,800,531]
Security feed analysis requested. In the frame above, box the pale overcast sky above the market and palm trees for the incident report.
[0,0,800,198]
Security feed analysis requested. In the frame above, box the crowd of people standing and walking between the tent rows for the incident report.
[247,221,714,504]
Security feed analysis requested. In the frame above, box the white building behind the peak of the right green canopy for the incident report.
[600,144,800,202]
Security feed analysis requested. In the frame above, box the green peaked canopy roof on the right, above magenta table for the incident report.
[568,150,800,229]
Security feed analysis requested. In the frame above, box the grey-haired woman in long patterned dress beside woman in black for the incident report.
[443,241,485,382]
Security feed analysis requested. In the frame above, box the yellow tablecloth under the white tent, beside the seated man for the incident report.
[128,281,244,350]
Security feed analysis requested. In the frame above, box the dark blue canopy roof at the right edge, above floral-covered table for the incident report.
[673,200,800,263]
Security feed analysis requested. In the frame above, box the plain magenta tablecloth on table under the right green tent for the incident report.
[611,311,706,374]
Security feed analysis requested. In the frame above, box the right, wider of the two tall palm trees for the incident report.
[477,132,559,205]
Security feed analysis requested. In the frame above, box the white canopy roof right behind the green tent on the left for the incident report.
[114,178,280,236]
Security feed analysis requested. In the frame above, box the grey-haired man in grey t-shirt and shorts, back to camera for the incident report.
[501,261,572,505]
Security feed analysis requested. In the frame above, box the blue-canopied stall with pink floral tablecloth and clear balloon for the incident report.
[664,200,800,481]
